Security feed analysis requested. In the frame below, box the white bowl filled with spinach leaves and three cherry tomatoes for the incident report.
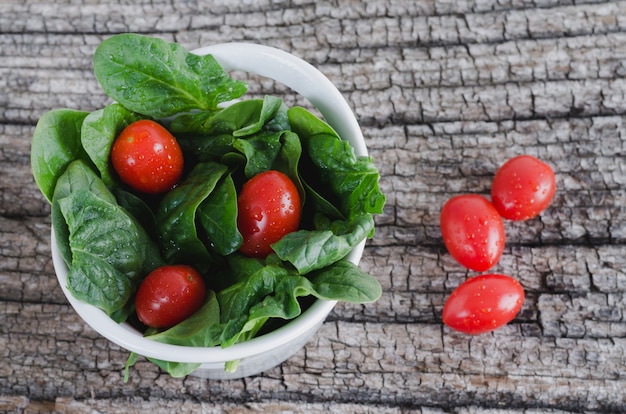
[31,34,385,379]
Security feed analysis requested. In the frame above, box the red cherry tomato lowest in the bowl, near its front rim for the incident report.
[135,265,206,328]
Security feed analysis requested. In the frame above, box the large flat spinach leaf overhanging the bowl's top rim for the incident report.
[94,33,247,119]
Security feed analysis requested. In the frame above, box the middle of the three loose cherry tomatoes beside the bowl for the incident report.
[440,194,506,272]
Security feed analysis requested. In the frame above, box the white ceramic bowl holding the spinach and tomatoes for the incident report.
[51,43,367,379]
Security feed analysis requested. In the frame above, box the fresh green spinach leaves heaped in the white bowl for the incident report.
[31,34,385,376]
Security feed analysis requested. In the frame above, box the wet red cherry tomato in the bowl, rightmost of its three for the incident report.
[237,170,300,258]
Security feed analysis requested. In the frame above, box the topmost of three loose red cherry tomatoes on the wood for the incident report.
[491,155,556,220]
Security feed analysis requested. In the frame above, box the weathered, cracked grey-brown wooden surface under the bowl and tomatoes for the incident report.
[0,0,626,413]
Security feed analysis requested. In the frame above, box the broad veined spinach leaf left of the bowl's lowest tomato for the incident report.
[58,189,160,322]
